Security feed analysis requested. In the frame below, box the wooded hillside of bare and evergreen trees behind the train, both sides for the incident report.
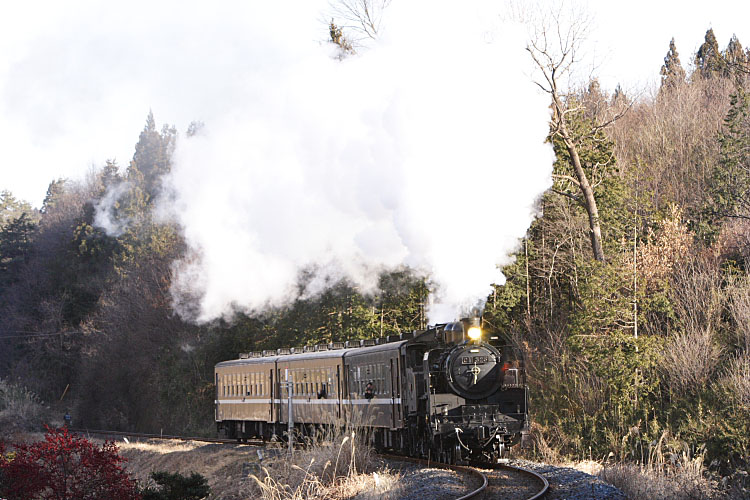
[0,30,750,492]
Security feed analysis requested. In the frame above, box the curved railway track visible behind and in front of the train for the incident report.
[70,428,549,500]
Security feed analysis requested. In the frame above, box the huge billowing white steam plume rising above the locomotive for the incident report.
[156,1,553,321]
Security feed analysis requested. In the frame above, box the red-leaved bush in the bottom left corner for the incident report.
[0,428,140,500]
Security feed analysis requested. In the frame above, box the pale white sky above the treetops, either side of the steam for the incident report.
[0,0,750,206]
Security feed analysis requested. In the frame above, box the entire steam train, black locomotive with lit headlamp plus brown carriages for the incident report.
[215,317,529,463]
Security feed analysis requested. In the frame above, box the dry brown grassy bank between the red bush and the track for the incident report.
[107,414,402,500]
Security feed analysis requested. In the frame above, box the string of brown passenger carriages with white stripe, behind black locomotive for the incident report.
[215,341,404,442]
